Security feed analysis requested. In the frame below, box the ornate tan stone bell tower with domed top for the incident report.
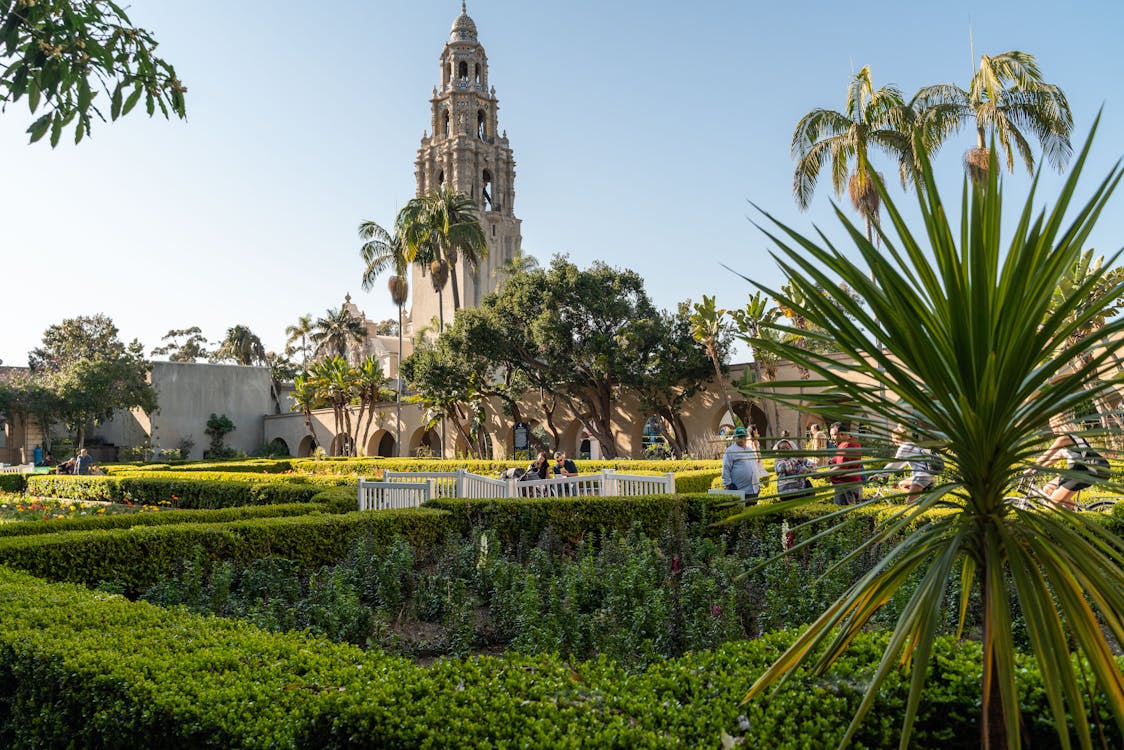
[410,0,523,332]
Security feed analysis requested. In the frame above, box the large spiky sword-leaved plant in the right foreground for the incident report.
[743,128,1124,748]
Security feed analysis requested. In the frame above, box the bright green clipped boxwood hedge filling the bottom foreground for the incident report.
[0,569,1124,750]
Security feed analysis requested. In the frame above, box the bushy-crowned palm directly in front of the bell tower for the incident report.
[396,187,488,331]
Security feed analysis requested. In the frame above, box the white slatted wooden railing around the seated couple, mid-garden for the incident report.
[359,469,676,510]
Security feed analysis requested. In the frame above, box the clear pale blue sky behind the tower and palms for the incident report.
[0,0,1124,364]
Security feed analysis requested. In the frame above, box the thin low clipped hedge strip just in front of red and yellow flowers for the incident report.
[0,503,329,537]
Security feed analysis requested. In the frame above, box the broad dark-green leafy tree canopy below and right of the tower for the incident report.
[402,256,713,457]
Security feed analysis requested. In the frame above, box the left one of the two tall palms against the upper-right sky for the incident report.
[791,65,914,241]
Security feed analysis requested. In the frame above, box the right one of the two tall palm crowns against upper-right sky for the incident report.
[910,49,1073,184]
